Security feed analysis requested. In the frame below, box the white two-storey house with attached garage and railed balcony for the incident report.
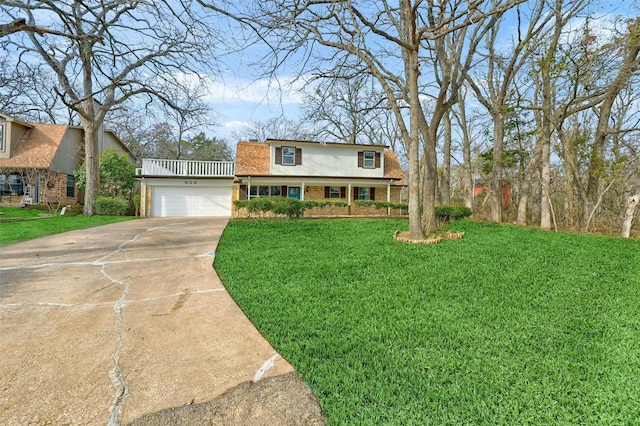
[138,139,406,217]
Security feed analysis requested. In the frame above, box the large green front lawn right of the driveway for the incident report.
[215,220,640,425]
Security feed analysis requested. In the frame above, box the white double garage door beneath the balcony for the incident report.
[151,186,231,217]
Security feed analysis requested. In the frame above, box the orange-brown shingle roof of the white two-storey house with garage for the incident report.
[236,141,407,185]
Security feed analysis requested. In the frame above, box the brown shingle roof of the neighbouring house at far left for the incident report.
[0,124,67,169]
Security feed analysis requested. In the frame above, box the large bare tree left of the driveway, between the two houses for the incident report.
[0,0,226,215]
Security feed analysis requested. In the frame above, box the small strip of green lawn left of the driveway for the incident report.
[0,207,133,246]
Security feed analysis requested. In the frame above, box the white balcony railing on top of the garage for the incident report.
[137,158,235,177]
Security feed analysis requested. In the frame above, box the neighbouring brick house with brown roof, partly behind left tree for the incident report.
[0,113,135,205]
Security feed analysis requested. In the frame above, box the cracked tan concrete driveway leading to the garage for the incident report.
[0,218,323,425]
